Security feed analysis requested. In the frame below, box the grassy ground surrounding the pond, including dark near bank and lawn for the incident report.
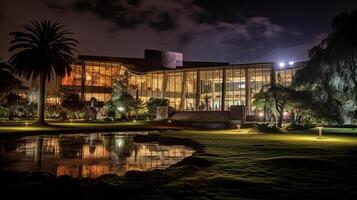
[0,119,357,199]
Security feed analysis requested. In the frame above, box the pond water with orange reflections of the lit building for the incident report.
[0,133,193,178]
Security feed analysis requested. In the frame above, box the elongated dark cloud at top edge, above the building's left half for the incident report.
[47,0,181,31]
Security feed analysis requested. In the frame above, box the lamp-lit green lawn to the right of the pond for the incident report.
[150,130,357,199]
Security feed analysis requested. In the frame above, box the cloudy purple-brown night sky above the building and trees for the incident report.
[0,0,357,63]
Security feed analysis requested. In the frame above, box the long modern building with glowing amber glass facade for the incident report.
[60,50,303,115]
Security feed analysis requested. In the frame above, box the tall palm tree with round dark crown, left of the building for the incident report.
[9,20,78,125]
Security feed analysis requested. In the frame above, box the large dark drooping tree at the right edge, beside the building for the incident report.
[294,10,357,121]
